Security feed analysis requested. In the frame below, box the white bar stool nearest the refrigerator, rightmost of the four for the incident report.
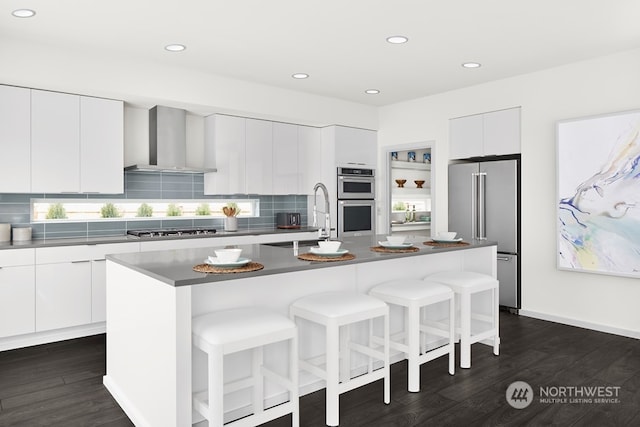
[424,271,500,368]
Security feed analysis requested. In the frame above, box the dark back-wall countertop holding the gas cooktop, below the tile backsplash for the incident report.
[0,227,318,250]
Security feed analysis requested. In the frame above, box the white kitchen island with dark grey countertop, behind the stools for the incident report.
[104,236,497,427]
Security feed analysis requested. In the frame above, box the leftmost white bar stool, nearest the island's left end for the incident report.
[192,307,300,427]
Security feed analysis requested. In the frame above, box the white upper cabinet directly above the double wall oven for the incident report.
[326,126,378,169]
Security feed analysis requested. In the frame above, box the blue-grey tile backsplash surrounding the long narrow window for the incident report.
[0,171,308,239]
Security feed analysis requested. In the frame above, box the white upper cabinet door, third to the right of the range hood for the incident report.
[273,122,299,194]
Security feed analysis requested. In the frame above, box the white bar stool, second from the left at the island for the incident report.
[289,292,391,426]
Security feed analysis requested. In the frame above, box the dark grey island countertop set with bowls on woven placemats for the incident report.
[107,236,497,286]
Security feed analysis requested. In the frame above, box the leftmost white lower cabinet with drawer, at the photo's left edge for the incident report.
[0,249,36,338]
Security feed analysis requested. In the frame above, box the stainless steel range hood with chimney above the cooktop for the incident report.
[124,105,216,173]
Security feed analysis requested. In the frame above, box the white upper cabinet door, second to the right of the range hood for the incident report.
[243,119,273,194]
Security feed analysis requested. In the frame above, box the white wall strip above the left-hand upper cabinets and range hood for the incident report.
[0,40,377,129]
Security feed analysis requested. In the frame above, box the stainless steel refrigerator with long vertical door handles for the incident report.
[449,158,521,310]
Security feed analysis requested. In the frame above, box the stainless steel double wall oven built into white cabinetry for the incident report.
[337,167,376,238]
